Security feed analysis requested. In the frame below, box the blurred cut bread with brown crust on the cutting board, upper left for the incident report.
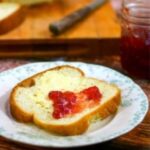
[0,2,25,34]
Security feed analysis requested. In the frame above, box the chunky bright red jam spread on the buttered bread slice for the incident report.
[48,86,102,119]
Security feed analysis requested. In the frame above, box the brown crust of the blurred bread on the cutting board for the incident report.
[0,6,26,34]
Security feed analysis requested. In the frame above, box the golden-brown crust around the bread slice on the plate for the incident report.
[10,65,121,135]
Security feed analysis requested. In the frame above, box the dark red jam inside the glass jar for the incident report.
[121,29,150,79]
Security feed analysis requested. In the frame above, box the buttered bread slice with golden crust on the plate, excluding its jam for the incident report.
[10,65,121,135]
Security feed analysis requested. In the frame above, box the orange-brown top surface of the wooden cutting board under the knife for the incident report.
[0,0,120,44]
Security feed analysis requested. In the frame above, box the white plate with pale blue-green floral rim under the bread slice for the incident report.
[0,62,148,147]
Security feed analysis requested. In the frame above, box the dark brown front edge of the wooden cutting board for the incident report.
[0,39,119,59]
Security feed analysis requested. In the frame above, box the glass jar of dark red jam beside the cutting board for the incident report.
[121,0,150,80]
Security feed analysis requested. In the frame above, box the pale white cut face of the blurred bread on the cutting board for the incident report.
[0,3,20,21]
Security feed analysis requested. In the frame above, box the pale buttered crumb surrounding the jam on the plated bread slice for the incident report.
[15,69,118,125]
